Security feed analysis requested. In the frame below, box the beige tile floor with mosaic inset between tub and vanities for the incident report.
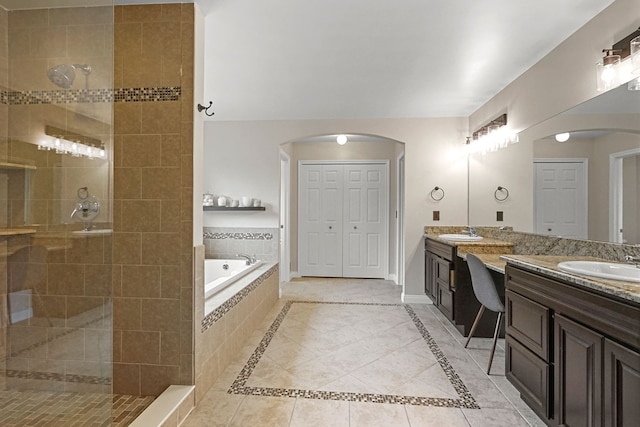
[183,278,544,427]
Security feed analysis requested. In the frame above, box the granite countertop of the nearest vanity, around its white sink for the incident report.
[500,254,640,304]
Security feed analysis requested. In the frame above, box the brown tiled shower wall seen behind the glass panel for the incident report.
[0,3,113,400]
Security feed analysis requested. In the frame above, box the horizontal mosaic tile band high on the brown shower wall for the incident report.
[0,86,182,105]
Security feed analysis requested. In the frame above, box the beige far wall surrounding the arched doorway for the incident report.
[204,118,467,301]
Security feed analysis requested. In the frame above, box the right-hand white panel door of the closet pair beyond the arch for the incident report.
[342,164,387,278]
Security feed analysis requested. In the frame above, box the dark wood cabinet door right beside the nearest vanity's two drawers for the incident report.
[555,314,604,427]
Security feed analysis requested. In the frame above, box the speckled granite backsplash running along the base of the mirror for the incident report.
[425,226,640,262]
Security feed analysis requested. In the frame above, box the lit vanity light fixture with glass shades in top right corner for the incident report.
[596,28,640,92]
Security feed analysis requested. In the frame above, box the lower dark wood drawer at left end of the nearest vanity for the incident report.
[505,335,552,419]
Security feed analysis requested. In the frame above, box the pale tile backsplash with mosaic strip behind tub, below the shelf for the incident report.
[203,227,278,262]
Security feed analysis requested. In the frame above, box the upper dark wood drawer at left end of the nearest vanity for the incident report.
[505,290,551,362]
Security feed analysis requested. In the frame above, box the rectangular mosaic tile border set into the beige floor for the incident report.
[227,301,480,409]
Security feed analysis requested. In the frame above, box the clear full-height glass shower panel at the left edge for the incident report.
[0,0,114,426]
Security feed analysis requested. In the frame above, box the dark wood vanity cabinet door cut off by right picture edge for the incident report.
[604,339,640,427]
